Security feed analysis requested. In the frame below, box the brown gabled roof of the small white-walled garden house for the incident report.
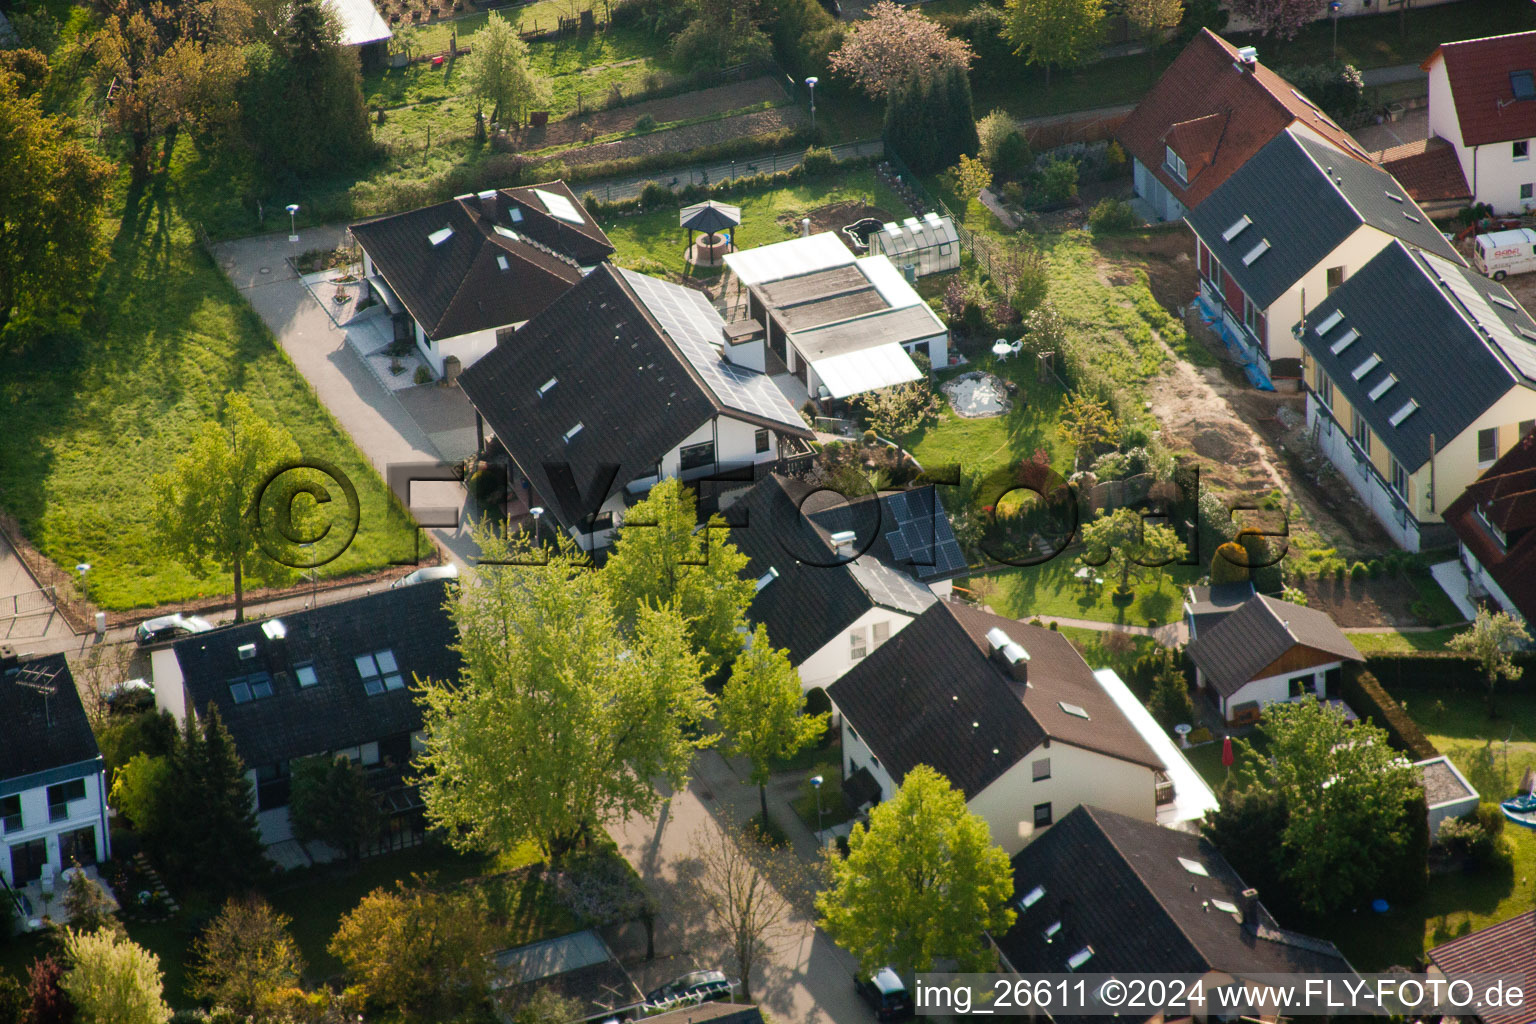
[1189,594,1362,697]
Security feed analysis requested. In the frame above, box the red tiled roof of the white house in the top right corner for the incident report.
[1422,32,1536,146]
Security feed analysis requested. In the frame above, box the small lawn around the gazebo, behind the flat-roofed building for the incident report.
[599,168,908,276]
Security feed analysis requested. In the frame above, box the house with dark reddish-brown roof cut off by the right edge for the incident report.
[1445,432,1536,622]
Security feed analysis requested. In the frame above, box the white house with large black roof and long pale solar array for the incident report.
[461,264,813,550]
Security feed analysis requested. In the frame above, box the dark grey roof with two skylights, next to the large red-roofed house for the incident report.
[1184,130,1461,308]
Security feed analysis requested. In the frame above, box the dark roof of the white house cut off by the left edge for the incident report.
[0,654,101,781]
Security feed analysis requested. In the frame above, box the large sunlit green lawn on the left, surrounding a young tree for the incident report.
[0,173,413,609]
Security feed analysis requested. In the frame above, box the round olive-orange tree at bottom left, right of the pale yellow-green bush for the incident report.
[190,897,304,1019]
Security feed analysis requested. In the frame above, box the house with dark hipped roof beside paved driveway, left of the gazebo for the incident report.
[352,181,613,376]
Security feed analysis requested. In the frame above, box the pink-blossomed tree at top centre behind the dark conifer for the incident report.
[829,0,975,100]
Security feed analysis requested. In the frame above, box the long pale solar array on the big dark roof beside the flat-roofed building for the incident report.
[619,270,805,430]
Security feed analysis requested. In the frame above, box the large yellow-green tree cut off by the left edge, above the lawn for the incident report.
[0,69,112,327]
